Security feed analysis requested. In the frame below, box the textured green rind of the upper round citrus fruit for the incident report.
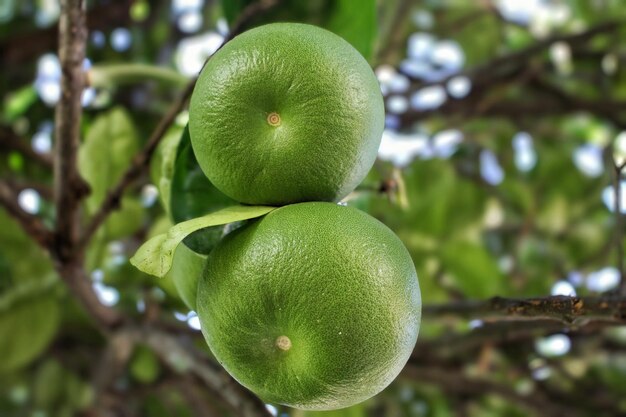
[189,23,384,205]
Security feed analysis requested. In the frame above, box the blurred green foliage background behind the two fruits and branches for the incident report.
[0,0,626,417]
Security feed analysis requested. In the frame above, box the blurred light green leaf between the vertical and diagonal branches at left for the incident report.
[78,107,139,213]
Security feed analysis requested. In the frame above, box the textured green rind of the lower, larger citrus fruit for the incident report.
[197,203,421,410]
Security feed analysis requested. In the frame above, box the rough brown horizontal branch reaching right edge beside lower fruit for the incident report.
[423,295,626,324]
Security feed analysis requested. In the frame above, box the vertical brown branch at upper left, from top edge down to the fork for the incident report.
[52,0,87,261]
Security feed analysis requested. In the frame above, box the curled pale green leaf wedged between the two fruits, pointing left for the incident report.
[130,206,276,277]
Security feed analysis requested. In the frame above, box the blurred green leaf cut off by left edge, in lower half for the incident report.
[0,275,60,373]
